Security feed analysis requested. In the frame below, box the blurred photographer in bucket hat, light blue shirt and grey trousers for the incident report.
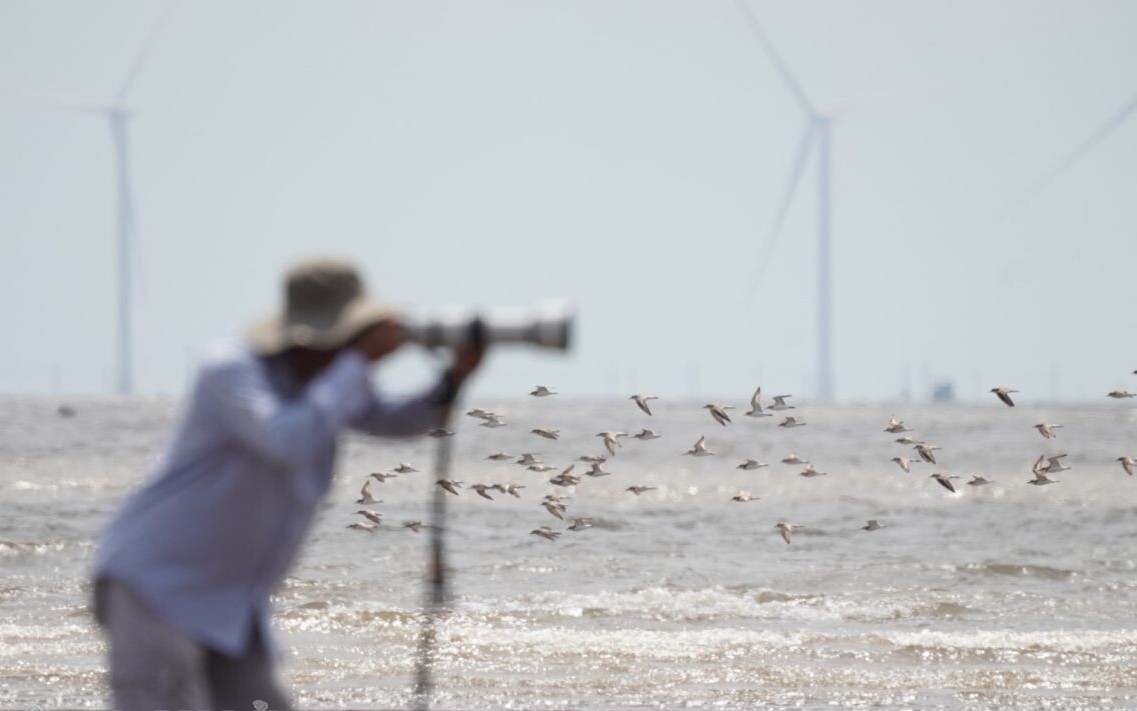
[94,261,482,711]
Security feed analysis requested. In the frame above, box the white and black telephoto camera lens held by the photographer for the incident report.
[401,301,573,350]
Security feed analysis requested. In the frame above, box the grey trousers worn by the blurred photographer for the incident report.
[94,580,292,711]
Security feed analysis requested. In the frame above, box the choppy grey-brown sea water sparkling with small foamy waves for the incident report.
[0,396,1137,710]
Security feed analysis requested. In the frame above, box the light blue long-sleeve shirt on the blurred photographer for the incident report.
[94,341,442,655]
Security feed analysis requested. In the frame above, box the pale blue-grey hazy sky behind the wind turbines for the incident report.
[0,0,1137,402]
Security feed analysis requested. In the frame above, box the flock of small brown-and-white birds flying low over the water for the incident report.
[348,379,1137,544]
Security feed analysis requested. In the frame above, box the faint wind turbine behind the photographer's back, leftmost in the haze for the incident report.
[89,5,171,395]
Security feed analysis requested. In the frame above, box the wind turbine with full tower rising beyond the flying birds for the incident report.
[735,0,835,400]
